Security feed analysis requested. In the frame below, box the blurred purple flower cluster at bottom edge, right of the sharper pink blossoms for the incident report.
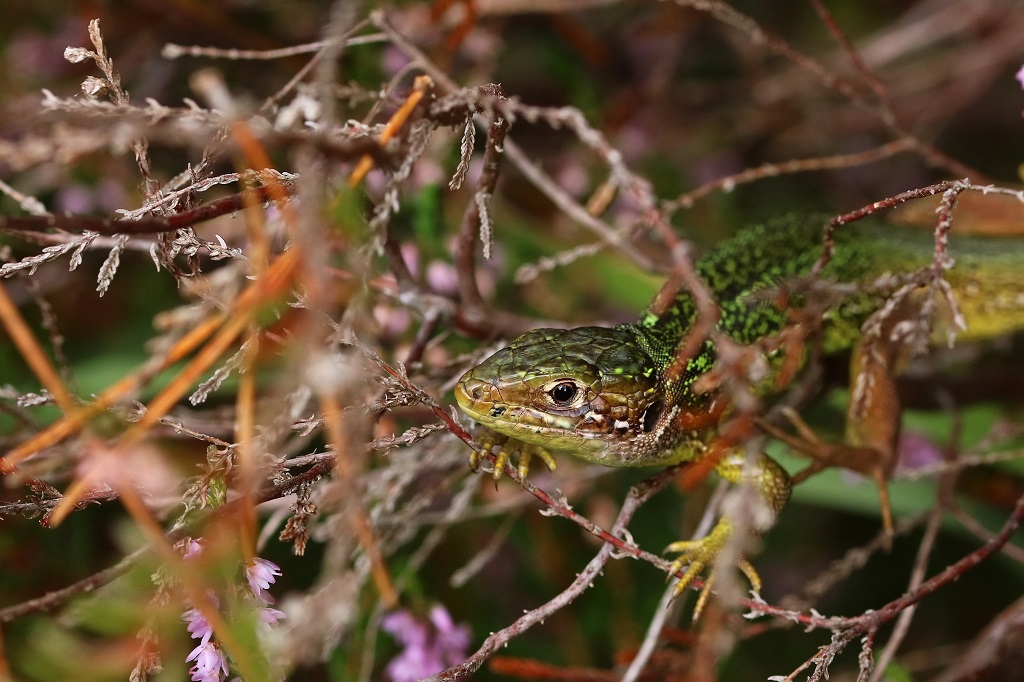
[381,605,470,682]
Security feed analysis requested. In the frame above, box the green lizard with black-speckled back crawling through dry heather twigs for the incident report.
[455,212,1024,615]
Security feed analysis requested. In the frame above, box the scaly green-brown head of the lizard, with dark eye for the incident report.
[455,327,665,466]
